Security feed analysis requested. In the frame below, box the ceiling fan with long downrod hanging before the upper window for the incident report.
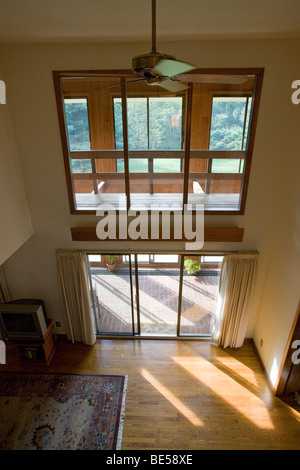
[132,0,248,93]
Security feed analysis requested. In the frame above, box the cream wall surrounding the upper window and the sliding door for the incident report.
[1,40,300,388]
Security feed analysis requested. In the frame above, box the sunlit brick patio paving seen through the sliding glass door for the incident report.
[92,267,219,336]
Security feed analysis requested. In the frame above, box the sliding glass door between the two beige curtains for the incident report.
[87,254,223,337]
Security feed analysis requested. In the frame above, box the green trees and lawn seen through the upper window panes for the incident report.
[65,96,251,173]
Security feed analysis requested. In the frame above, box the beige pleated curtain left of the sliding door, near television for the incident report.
[56,250,96,345]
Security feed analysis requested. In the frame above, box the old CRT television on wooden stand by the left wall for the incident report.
[0,299,48,338]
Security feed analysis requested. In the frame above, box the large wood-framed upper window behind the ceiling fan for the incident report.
[54,69,263,214]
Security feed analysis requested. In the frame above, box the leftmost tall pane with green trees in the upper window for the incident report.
[64,98,91,151]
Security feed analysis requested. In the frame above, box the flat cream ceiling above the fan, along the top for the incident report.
[0,0,300,43]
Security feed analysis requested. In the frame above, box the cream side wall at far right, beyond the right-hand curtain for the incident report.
[254,100,300,386]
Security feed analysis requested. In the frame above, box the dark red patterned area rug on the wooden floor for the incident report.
[0,373,127,450]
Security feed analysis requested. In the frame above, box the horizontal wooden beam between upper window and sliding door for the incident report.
[71,227,244,243]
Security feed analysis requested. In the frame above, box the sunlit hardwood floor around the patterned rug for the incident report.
[0,339,300,450]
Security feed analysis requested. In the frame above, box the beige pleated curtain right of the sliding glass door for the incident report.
[212,254,258,348]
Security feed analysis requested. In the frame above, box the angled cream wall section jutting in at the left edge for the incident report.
[0,64,33,265]
